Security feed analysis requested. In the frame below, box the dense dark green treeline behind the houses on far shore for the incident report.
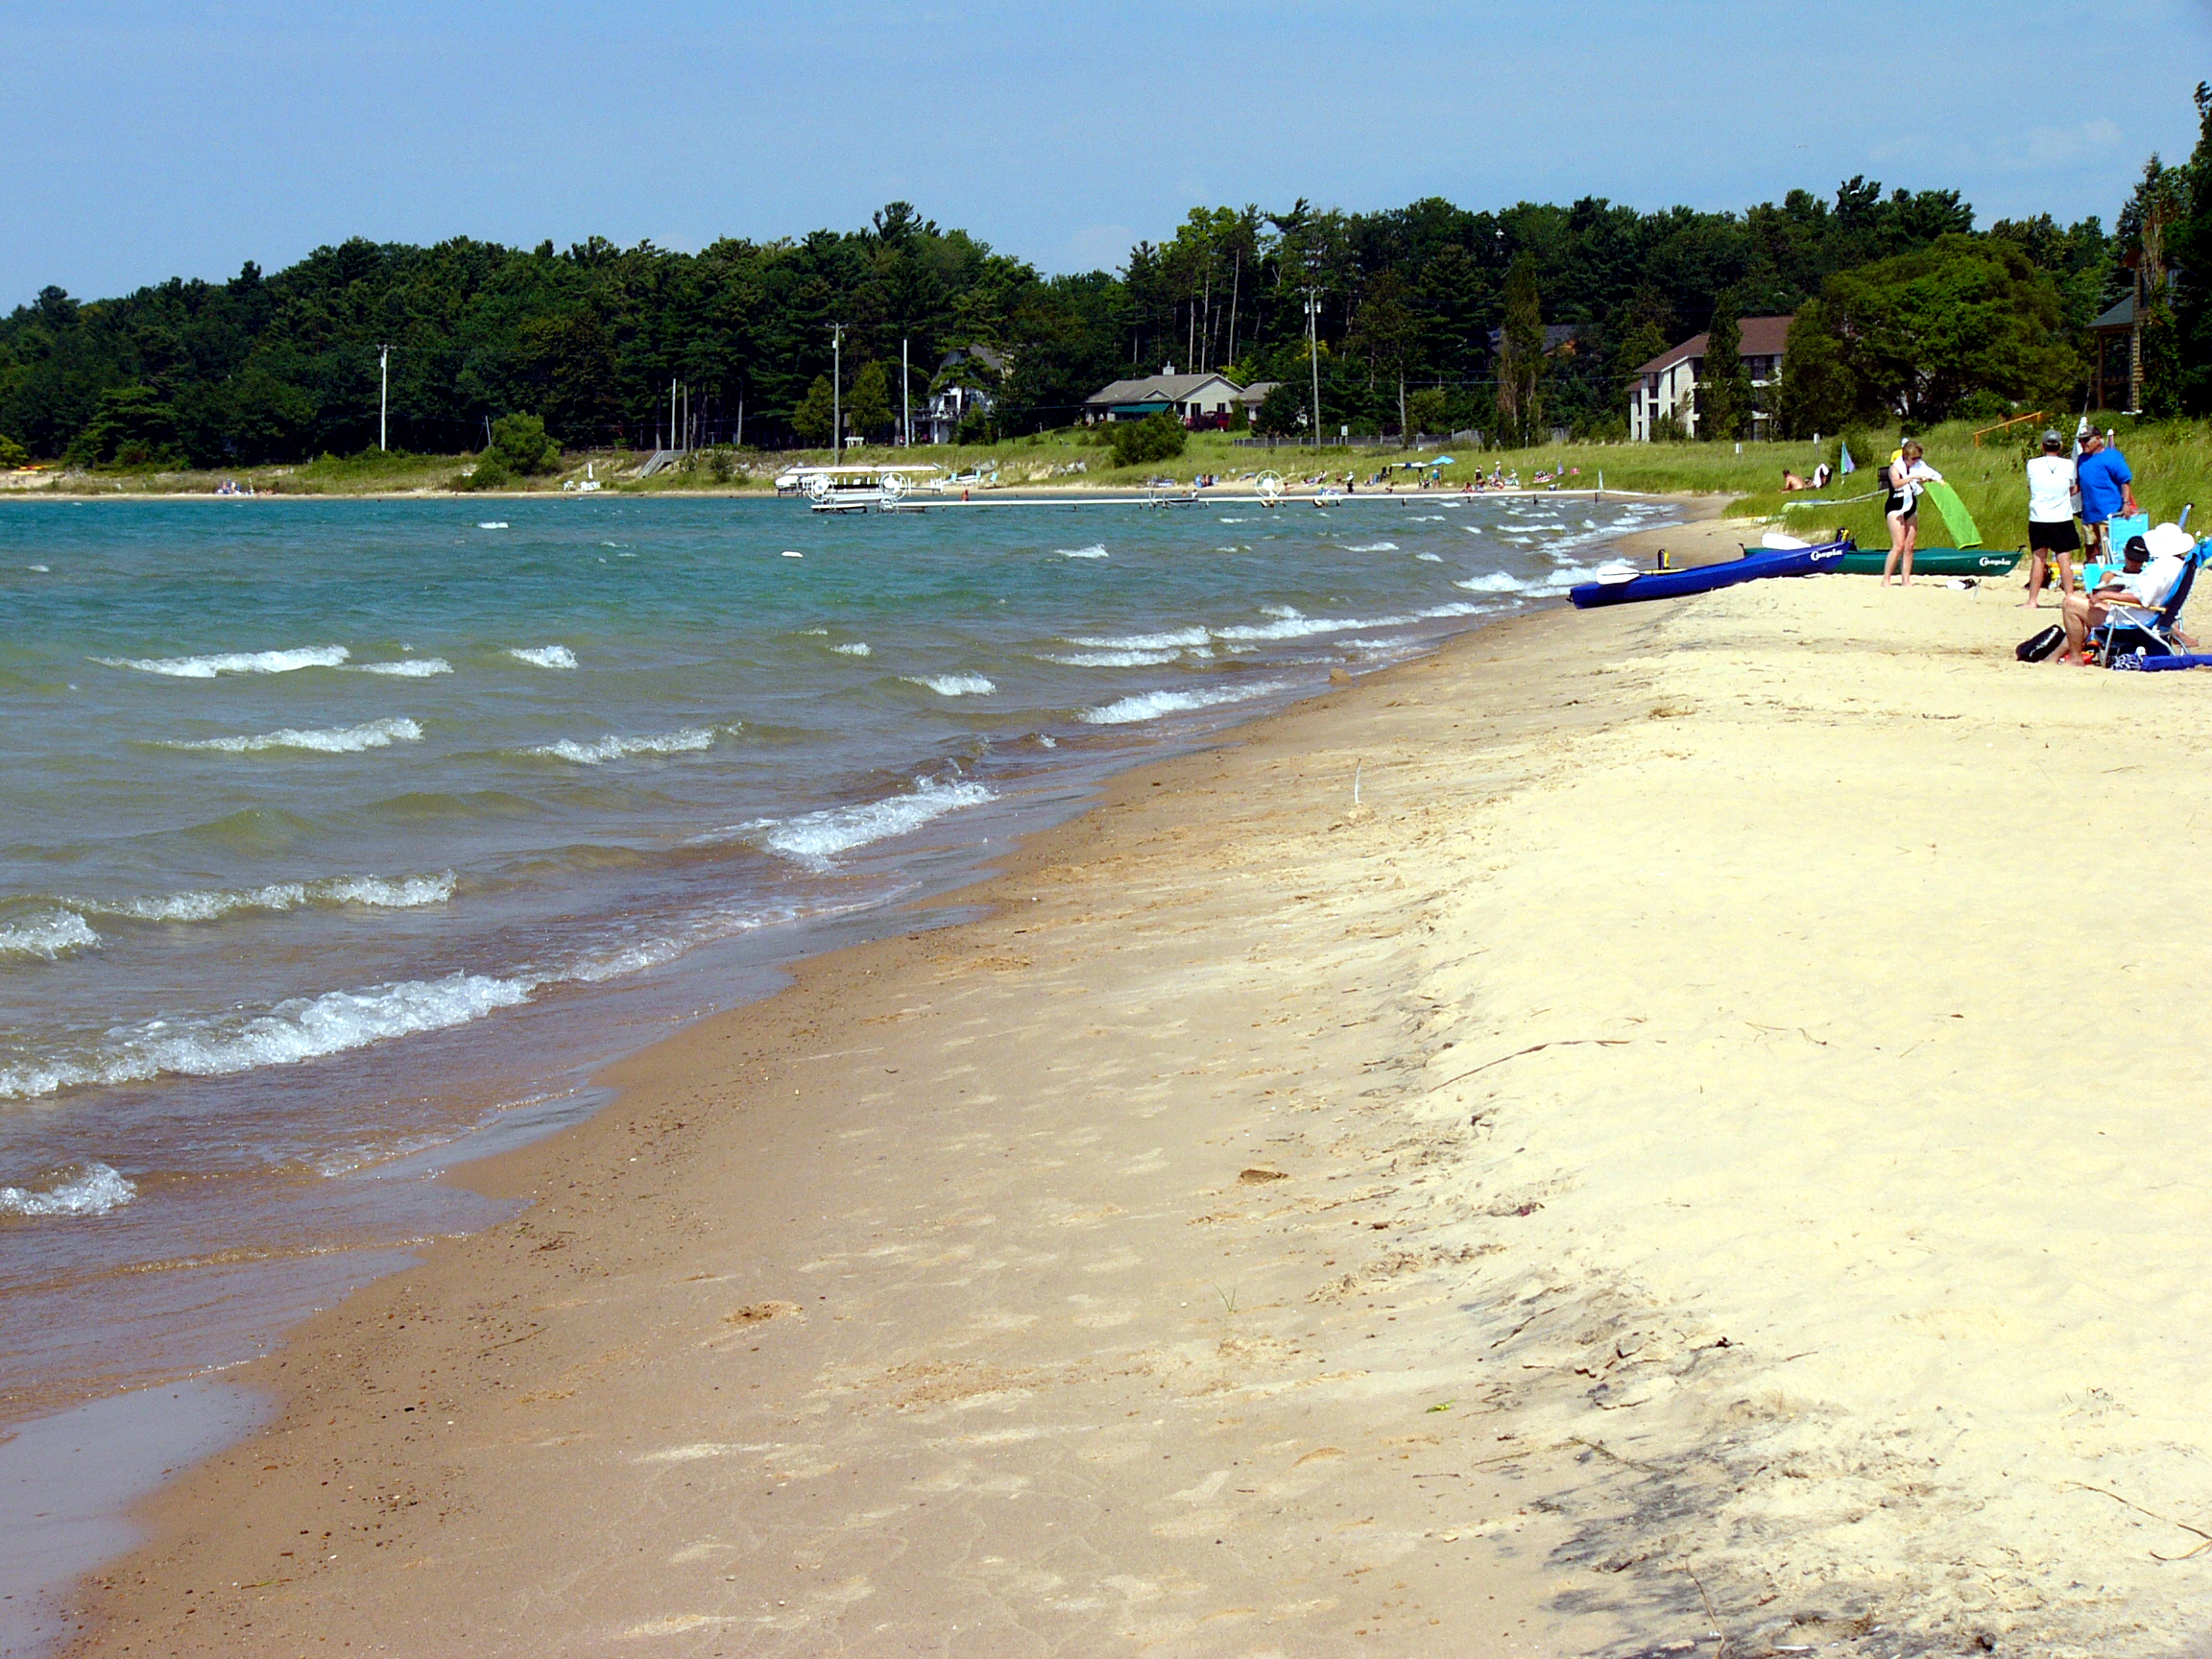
[0,88,2212,467]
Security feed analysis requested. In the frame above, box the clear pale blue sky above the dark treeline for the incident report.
[0,0,2212,307]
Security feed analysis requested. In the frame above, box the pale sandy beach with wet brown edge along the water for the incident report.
[47,562,2212,1659]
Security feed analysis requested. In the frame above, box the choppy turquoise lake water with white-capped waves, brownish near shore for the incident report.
[0,484,1657,1416]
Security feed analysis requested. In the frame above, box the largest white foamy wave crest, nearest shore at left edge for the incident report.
[0,974,544,1099]
